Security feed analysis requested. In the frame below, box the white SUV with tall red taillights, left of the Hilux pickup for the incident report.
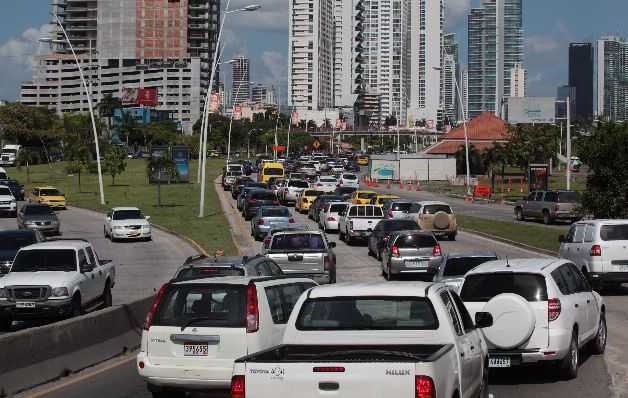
[137,277,316,397]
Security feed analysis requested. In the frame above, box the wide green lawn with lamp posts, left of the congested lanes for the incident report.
[6,159,237,254]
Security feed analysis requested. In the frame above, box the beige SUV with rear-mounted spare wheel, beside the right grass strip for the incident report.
[406,201,458,240]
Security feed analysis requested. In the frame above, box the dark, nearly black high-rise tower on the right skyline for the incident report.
[569,43,593,117]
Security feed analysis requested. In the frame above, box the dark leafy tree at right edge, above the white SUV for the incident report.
[580,122,628,218]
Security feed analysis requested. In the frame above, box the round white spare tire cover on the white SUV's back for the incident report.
[482,293,536,349]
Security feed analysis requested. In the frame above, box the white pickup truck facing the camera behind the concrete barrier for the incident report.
[0,240,115,330]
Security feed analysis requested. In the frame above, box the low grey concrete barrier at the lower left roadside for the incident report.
[0,297,153,396]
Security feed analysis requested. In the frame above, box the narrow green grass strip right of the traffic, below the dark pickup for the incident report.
[456,214,565,253]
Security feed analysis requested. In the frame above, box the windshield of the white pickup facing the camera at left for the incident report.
[11,249,76,272]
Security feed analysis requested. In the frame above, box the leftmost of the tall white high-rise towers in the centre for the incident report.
[288,0,334,110]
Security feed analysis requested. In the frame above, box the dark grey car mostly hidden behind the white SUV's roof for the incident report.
[173,254,283,280]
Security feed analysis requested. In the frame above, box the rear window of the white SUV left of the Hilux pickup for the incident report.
[153,284,246,328]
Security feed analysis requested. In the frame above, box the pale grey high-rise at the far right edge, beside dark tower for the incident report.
[597,36,628,121]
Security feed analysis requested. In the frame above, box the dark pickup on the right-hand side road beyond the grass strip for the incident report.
[514,190,582,224]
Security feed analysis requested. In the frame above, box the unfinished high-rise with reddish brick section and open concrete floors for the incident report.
[20,0,220,133]
